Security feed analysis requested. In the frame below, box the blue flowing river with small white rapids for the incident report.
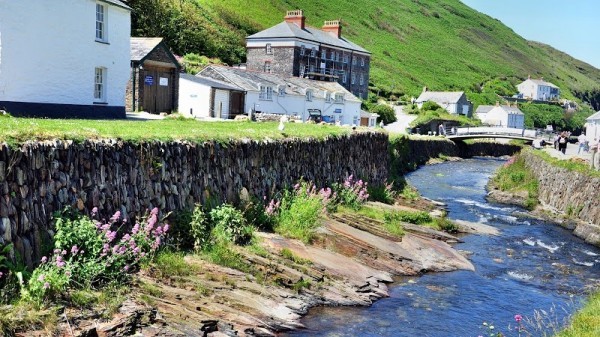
[287,159,600,337]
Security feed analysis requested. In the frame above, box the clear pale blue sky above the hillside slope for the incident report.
[461,0,600,68]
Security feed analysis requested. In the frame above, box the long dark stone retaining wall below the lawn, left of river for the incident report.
[0,133,388,266]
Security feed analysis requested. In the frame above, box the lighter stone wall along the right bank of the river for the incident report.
[523,151,600,246]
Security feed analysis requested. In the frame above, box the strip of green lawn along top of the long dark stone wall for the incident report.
[0,117,366,144]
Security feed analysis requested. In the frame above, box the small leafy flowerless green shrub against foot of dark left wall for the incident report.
[210,204,254,244]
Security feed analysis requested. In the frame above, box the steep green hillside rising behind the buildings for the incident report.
[129,0,600,108]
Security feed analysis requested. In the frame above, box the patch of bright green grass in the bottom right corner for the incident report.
[555,292,600,337]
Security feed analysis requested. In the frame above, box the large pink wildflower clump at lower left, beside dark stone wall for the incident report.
[22,208,169,303]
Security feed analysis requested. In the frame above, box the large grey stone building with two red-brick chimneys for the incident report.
[246,10,371,99]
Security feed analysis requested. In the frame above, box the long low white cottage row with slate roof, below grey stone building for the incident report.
[179,65,377,126]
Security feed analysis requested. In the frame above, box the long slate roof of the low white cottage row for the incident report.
[198,65,360,102]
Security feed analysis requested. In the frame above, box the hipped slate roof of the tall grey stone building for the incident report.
[246,21,371,54]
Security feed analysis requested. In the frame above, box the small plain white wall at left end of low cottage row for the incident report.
[179,78,211,117]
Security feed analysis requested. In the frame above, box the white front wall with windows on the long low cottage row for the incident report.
[244,88,360,125]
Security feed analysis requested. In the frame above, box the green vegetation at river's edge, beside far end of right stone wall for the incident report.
[492,155,539,210]
